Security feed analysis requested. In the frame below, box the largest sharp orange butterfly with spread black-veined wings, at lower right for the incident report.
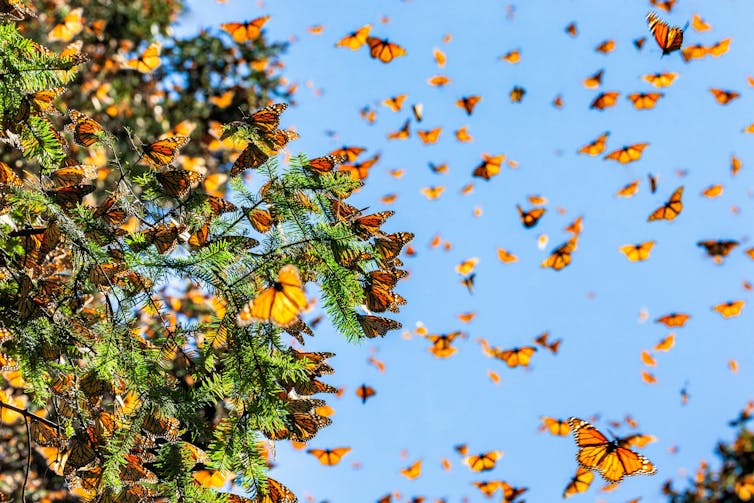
[568,417,657,483]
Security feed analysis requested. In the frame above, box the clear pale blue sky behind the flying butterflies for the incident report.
[181,0,754,503]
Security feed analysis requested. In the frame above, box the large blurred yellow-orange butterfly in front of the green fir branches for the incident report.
[238,264,309,327]
